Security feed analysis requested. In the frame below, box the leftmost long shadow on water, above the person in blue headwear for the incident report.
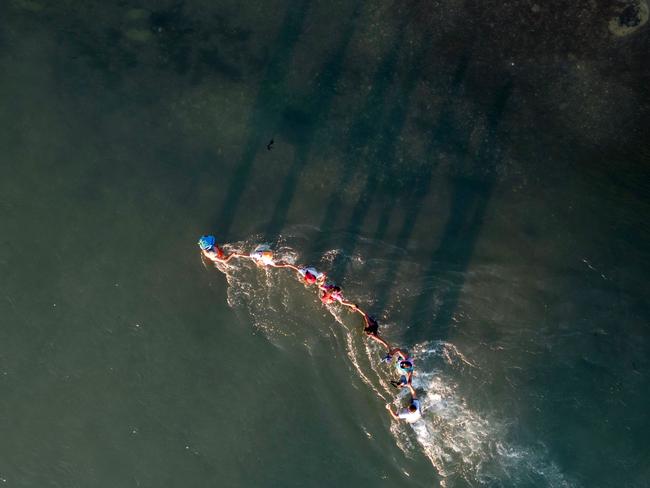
[212,0,310,235]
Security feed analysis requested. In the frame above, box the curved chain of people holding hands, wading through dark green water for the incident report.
[198,235,421,422]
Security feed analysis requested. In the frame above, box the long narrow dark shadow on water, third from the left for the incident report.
[309,15,406,260]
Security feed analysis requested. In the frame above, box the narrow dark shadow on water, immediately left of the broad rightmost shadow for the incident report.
[364,49,472,318]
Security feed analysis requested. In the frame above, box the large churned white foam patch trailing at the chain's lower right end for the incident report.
[412,342,573,486]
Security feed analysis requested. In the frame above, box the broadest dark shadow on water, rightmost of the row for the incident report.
[409,80,513,342]
